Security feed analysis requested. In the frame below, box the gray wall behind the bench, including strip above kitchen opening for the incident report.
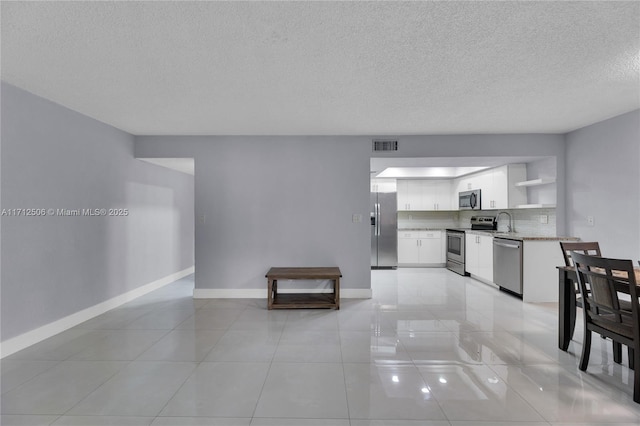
[136,135,564,289]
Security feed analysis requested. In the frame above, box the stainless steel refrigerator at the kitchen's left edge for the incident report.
[371,192,398,269]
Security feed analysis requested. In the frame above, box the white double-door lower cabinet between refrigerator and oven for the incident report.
[398,231,445,266]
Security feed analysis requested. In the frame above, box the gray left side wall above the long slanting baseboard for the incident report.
[1,83,194,340]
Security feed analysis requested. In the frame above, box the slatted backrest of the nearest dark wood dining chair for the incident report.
[572,252,640,341]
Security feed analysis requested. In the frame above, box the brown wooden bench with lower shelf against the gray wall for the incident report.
[266,267,342,310]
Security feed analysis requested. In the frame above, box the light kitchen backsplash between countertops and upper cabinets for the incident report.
[398,208,556,237]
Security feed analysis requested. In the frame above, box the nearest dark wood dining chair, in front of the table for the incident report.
[572,252,640,403]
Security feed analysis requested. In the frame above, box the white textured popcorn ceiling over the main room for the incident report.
[1,1,640,135]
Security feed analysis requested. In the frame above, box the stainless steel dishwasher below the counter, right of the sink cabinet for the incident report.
[493,238,522,298]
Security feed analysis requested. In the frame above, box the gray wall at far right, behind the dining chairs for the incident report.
[566,110,640,262]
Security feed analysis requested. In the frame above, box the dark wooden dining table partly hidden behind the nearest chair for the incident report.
[557,266,640,351]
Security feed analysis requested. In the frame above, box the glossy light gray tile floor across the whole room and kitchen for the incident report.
[0,269,640,426]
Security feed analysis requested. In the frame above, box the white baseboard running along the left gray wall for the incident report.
[0,266,195,358]
